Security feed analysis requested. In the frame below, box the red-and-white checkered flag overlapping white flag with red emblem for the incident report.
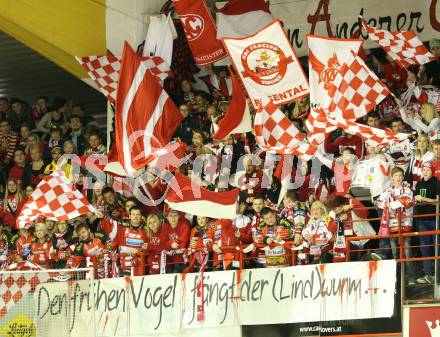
[324,54,391,121]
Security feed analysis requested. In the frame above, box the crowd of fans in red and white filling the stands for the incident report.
[0,40,440,283]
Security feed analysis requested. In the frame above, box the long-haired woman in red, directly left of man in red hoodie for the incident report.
[145,214,166,275]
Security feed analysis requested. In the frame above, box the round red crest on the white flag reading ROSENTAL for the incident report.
[241,42,293,85]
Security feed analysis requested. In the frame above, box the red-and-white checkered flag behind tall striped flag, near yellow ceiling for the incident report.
[76,52,171,104]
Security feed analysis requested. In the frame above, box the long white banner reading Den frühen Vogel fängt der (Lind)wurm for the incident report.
[34,260,396,336]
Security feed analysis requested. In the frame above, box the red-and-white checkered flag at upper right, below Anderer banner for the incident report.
[362,17,437,68]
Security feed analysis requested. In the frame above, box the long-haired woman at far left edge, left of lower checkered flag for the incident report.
[0,178,24,229]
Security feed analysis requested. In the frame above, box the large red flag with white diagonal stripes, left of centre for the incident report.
[115,43,183,175]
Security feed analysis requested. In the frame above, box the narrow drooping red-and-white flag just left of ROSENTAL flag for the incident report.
[212,70,252,139]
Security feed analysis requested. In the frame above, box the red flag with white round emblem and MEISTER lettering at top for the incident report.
[173,0,226,65]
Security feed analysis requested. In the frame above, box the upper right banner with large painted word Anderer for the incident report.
[270,0,440,56]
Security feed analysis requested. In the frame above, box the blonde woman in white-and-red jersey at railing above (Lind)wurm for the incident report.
[302,201,338,263]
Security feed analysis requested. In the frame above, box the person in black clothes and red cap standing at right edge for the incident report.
[414,161,438,284]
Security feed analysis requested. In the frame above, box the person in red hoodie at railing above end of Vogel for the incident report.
[162,210,191,273]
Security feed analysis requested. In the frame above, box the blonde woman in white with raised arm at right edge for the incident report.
[398,102,440,140]
